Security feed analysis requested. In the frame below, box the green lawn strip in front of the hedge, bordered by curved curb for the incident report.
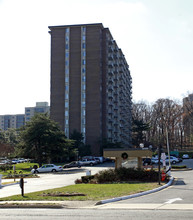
[0,182,160,201]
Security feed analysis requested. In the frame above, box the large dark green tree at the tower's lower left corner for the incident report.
[18,114,66,166]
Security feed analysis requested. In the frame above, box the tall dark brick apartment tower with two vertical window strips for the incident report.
[49,23,132,155]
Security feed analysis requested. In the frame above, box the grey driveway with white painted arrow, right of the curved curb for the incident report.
[97,159,193,210]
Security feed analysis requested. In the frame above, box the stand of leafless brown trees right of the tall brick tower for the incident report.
[133,99,183,148]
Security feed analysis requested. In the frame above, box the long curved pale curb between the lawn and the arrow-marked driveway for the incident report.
[95,177,174,205]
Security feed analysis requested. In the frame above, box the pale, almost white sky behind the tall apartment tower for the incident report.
[0,0,193,115]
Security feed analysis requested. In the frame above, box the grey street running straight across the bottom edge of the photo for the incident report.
[1,209,193,220]
